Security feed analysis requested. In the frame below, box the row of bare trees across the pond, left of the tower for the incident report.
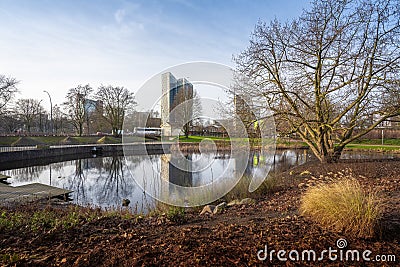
[0,79,136,137]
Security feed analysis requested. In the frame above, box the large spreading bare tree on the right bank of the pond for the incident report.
[235,0,400,162]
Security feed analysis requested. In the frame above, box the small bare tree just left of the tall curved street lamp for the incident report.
[14,98,43,133]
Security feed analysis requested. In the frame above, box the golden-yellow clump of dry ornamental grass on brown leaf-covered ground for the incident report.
[300,176,384,238]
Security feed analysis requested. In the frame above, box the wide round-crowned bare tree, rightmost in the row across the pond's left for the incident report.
[96,85,136,136]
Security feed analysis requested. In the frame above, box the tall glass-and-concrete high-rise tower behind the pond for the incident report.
[161,72,193,136]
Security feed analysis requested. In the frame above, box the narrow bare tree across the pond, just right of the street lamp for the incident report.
[64,84,93,136]
